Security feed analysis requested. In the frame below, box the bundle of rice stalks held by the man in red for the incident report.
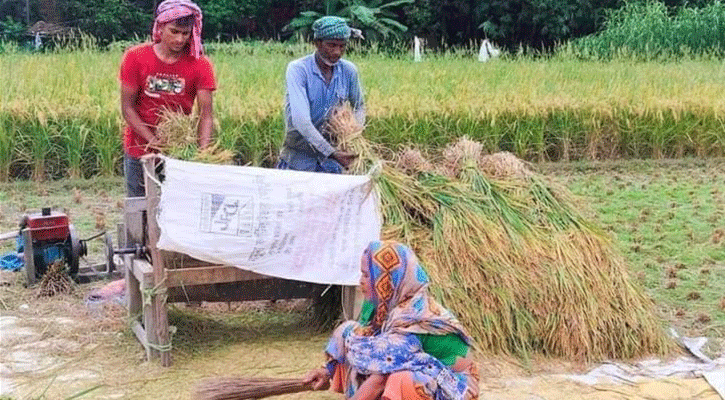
[153,109,234,164]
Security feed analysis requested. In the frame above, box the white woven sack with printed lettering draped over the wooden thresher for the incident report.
[157,158,381,285]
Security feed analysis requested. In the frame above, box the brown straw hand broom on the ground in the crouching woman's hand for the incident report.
[194,377,312,400]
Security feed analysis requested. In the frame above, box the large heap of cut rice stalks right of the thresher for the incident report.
[330,101,671,361]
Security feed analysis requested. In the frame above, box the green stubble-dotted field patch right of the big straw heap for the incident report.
[545,159,725,338]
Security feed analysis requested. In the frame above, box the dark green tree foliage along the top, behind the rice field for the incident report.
[0,0,715,50]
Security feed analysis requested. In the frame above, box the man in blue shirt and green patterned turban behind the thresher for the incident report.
[277,16,365,174]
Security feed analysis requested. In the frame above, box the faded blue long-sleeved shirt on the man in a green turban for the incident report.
[280,54,365,164]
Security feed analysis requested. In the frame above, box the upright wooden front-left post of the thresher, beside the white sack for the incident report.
[141,156,171,367]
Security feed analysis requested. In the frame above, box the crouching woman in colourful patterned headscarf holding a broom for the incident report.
[305,242,478,400]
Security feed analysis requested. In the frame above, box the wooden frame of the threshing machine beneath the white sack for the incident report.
[118,155,359,366]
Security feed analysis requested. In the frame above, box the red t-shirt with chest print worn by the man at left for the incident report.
[119,43,216,158]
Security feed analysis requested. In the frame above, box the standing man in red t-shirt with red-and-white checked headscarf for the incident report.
[119,0,216,197]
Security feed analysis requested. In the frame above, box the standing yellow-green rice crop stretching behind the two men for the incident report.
[0,43,725,177]
